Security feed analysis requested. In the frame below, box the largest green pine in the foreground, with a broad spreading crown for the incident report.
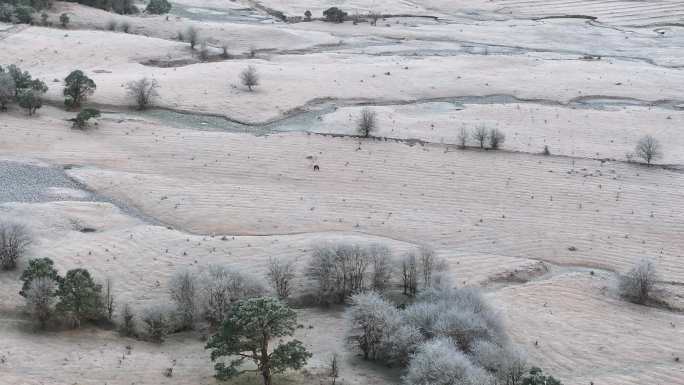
[206,297,311,385]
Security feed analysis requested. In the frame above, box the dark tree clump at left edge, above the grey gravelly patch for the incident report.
[0,64,48,116]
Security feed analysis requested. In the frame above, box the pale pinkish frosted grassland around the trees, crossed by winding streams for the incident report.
[0,0,684,385]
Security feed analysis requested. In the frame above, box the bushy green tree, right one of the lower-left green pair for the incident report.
[57,269,103,323]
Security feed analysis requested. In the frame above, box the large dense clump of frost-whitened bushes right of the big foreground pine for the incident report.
[345,282,555,385]
